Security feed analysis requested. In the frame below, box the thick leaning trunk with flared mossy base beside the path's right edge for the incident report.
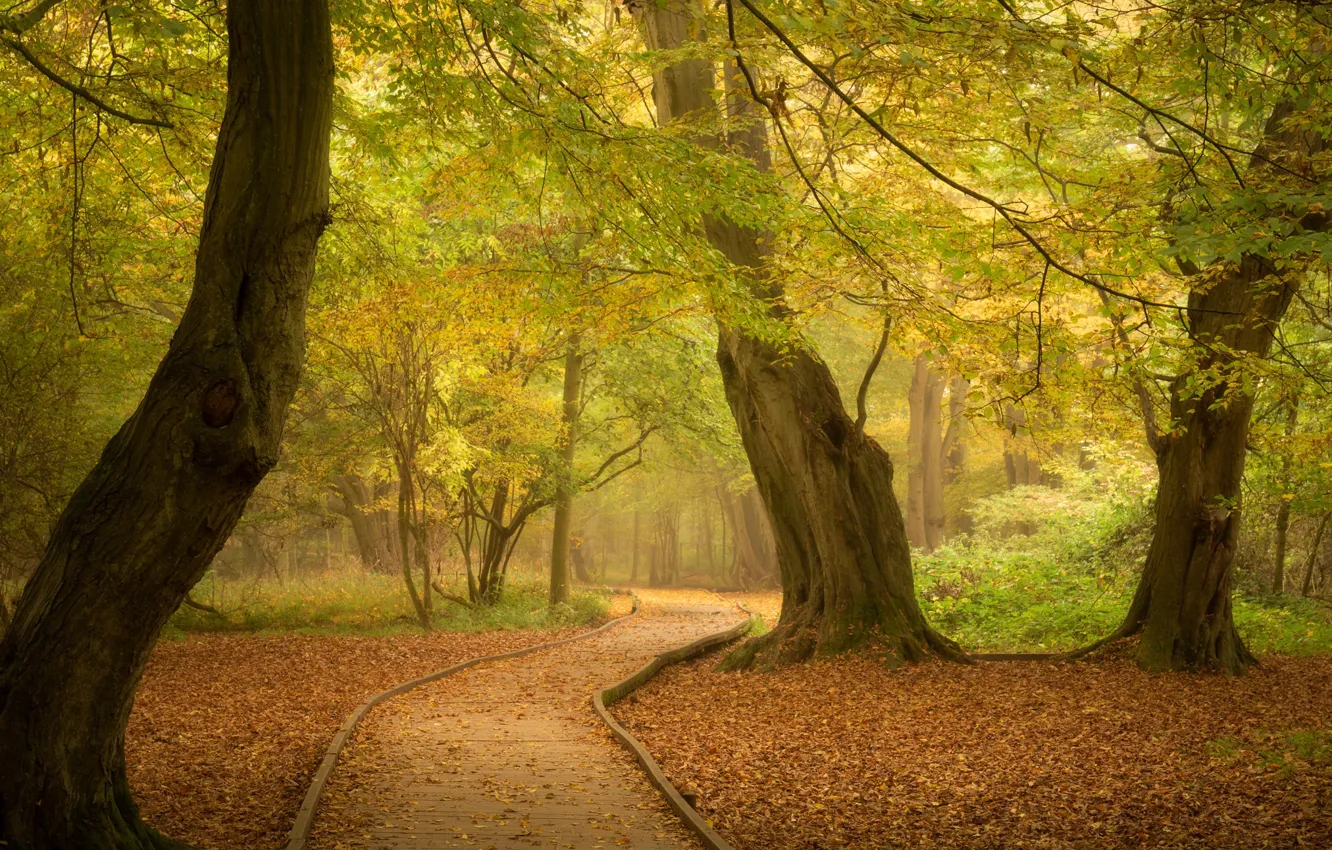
[631,0,962,667]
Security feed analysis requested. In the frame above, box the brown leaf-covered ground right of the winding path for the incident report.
[615,655,1332,850]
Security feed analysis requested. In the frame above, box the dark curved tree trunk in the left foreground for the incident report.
[0,0,333,850]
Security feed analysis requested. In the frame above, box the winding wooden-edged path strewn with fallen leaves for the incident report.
[310,590,745,850]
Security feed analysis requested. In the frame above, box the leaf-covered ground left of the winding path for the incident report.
[125,597,630,850]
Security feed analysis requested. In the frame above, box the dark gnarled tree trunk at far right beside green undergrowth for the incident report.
[1086,103,1328,673]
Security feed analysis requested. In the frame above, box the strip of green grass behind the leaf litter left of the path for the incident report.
[164,570,610,639]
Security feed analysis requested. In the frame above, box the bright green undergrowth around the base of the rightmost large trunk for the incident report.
[915,470,1332,654]
